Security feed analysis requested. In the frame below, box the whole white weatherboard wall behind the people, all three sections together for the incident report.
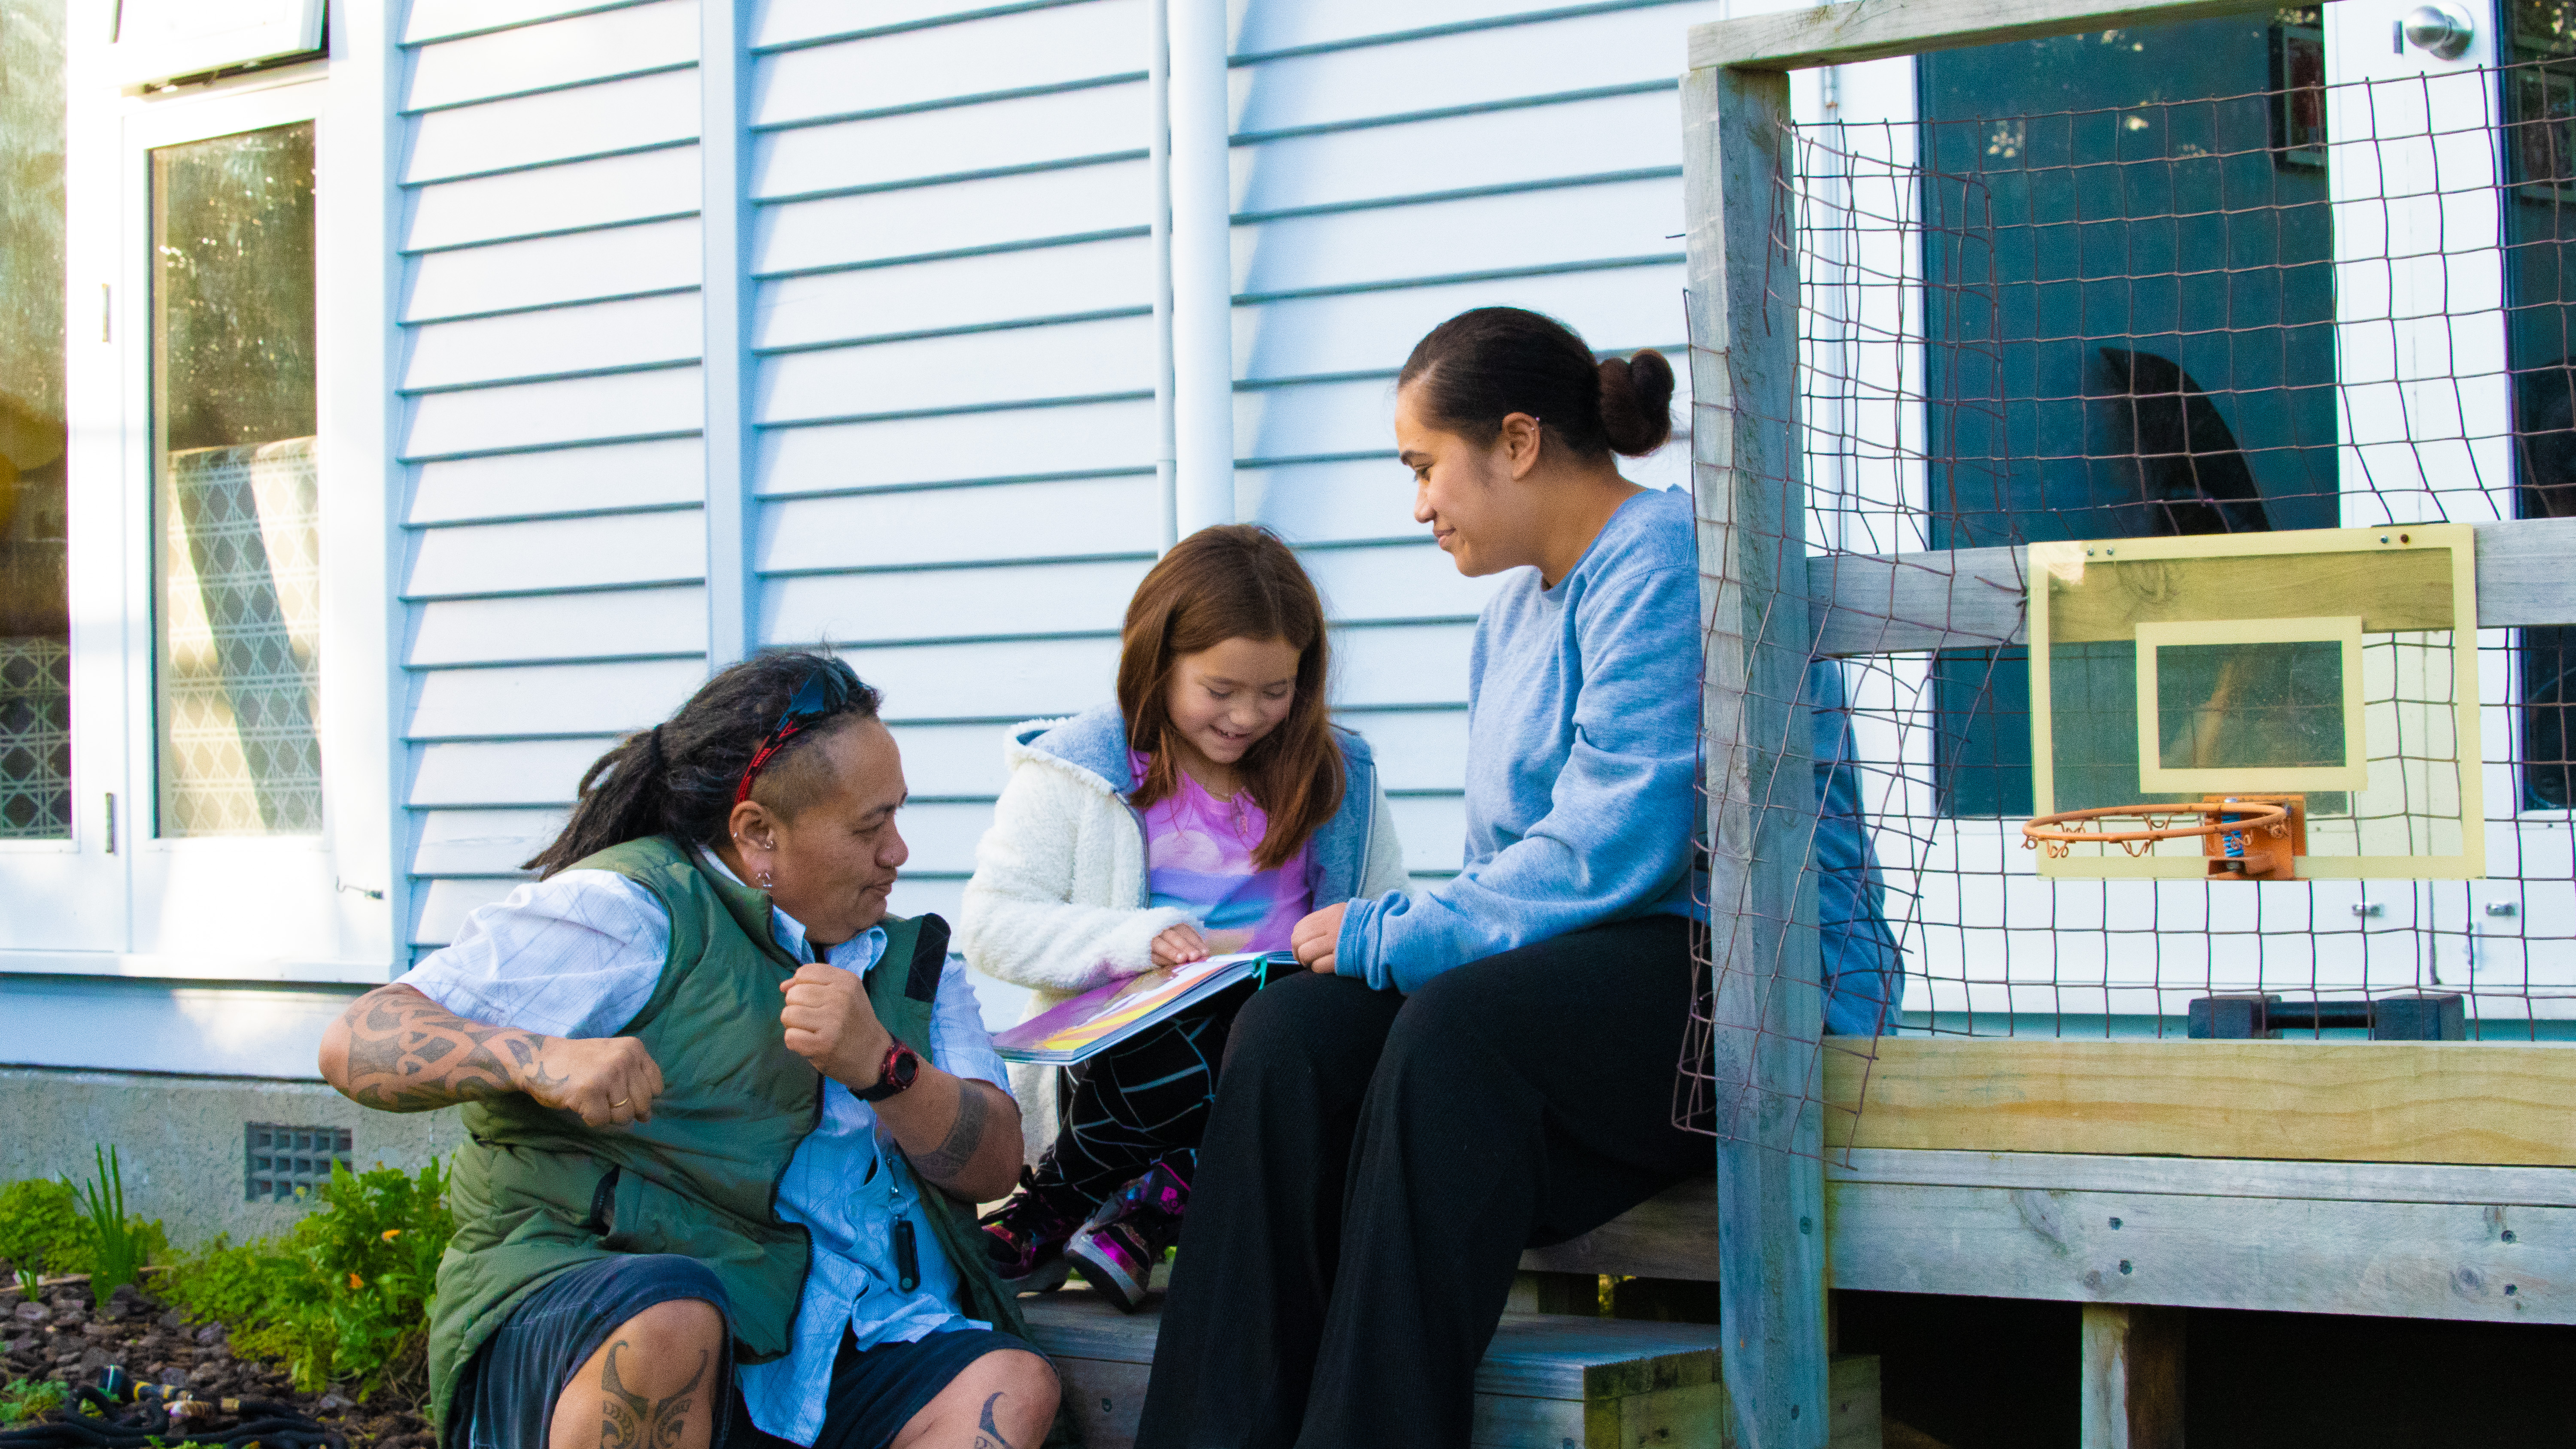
[386,0,1716,983]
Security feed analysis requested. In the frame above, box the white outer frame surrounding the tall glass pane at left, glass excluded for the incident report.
[0,23,404,983]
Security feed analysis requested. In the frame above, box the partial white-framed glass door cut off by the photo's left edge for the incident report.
[0,0,126,955]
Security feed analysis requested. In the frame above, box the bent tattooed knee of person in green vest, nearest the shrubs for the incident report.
[546,1297,729,1449]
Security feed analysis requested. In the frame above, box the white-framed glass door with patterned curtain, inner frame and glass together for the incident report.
[124,82,353,963]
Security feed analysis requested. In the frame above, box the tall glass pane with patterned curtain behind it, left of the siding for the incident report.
[152,124,322,837]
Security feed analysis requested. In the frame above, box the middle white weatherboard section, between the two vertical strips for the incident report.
[750,0,1162,942]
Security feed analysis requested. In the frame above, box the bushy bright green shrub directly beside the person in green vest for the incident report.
[157,1163,456,1397]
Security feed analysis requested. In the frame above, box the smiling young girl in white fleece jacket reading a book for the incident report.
[958,525,1404,1310]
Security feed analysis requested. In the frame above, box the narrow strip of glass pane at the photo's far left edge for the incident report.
[0,0,72,839]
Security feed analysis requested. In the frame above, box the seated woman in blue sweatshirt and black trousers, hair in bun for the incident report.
[1139,306,1893,1449]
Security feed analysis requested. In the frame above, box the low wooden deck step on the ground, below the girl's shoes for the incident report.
[1020,1289,1878,1449]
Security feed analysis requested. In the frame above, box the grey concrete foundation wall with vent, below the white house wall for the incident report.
[0,1068,464,1248]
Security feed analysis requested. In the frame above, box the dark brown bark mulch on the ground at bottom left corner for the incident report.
[0,1284,435,1449]
